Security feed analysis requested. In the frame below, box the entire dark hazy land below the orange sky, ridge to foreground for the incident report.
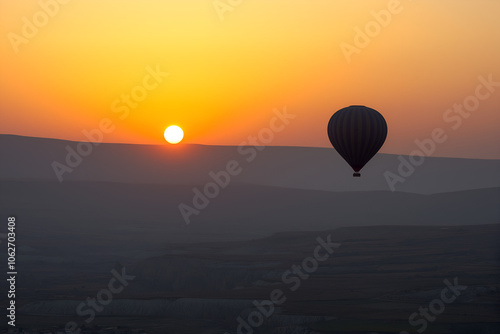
[0,135,500,334]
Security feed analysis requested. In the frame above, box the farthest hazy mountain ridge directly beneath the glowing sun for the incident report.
[0,135,500,194]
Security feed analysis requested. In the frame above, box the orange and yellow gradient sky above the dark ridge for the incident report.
[0,0,500,158]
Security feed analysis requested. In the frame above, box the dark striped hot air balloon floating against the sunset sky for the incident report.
[328,106,387,177]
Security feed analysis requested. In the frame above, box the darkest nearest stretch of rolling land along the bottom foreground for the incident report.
[7,224,500,334]
